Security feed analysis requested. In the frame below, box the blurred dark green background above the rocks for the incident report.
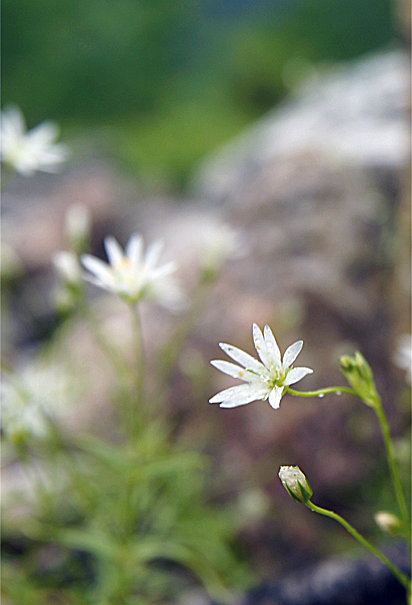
[2,0,396,186]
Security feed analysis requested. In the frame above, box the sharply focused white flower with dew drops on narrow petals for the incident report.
[209,324,313,410]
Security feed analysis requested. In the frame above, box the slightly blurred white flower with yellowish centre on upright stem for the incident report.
[80,233,184,310]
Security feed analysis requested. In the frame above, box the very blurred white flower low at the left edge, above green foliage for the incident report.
[1,363,69,441]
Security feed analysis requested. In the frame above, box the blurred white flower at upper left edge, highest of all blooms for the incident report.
[1,106,69,176]
